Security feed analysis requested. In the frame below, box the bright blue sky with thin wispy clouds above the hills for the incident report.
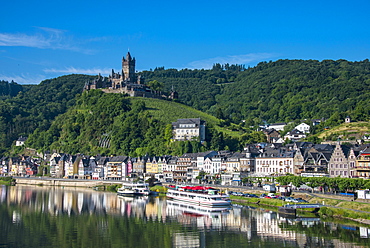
[0,0,370,84]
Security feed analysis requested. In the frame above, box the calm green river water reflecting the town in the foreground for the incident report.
[0,186,370,248]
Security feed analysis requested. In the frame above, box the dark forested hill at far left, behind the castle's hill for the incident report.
[0,75,94,154]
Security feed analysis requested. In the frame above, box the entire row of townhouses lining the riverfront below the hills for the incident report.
[0,142,370,184]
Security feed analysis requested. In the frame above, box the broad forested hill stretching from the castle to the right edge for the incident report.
[143,60,370,125]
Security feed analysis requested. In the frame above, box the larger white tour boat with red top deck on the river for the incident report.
[167,186,231,207]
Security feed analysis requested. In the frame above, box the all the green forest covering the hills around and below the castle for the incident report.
[0,60,370,155]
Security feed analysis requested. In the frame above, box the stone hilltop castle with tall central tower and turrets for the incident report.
[84,52,177,99]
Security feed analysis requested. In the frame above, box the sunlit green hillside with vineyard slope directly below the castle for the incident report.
[26,90,254,156]
